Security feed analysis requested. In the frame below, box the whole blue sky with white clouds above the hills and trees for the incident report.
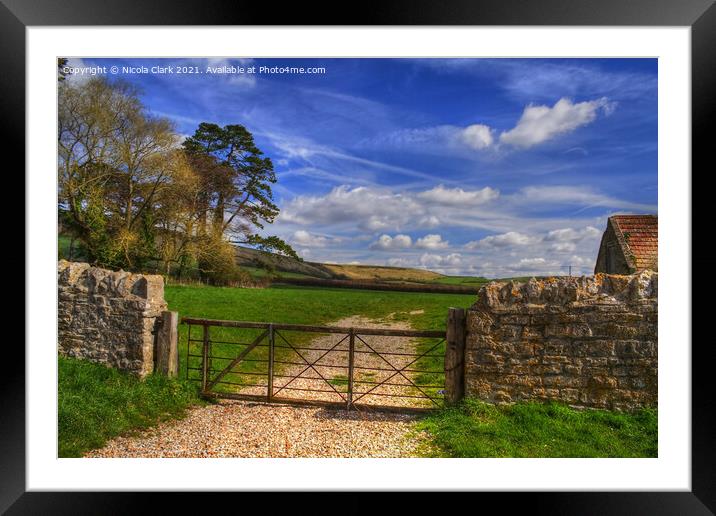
[70,58,657,277]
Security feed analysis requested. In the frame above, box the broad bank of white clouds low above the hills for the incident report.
[278,185,644,278]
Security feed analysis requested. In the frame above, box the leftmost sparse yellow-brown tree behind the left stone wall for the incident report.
[58,78,177,268]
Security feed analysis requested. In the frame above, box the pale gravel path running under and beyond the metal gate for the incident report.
[86,317,436,457]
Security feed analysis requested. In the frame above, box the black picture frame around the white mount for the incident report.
[0,0,716,515]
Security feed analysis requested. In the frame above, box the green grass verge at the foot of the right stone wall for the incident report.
[417,399,658,457]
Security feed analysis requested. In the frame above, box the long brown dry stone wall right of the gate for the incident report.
[465,271,658,410]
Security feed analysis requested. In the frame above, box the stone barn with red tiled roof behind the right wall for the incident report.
[594,215,659,274]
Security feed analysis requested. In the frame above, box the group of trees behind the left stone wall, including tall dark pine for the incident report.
[58,72,296,283]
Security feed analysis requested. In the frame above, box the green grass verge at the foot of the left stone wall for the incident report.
[57,357,202,457]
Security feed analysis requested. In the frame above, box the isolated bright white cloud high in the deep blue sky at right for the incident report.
[500,97,614,149]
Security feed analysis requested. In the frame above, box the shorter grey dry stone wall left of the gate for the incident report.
[57,260,167,376]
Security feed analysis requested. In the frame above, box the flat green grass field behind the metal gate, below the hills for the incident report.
[165,285,475,392]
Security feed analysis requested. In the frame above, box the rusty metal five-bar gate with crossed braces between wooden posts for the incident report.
[182,318,445,410]
